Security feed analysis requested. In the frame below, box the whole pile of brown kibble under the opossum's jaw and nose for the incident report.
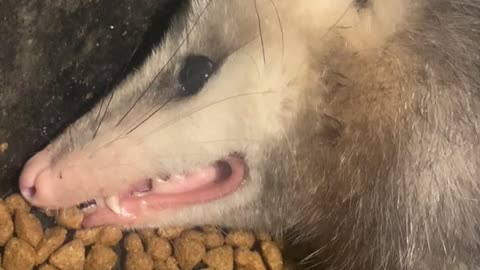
[0,194,283,270]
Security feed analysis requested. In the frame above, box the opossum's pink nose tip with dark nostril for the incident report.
[19,149,56,206]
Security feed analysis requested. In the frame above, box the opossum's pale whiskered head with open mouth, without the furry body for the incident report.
[20,0,402,232]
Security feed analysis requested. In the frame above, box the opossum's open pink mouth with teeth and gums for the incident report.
[80,155,247,227]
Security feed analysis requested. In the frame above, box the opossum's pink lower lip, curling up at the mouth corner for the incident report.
[79,157,247,227]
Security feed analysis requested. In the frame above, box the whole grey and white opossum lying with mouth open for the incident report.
[15,0,480,269]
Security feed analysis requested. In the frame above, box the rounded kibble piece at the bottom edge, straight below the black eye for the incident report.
[173,237,206,270]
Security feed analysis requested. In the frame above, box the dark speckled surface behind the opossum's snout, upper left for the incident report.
[0,0,185,197]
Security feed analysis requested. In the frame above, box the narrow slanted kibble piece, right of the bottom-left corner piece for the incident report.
[36,227,67,265]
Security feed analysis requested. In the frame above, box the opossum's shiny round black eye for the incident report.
[178,55,216,96]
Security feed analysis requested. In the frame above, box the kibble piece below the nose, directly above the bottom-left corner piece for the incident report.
[15,211,43,247]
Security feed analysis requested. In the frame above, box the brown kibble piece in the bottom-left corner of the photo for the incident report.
[3,237,35,270]
